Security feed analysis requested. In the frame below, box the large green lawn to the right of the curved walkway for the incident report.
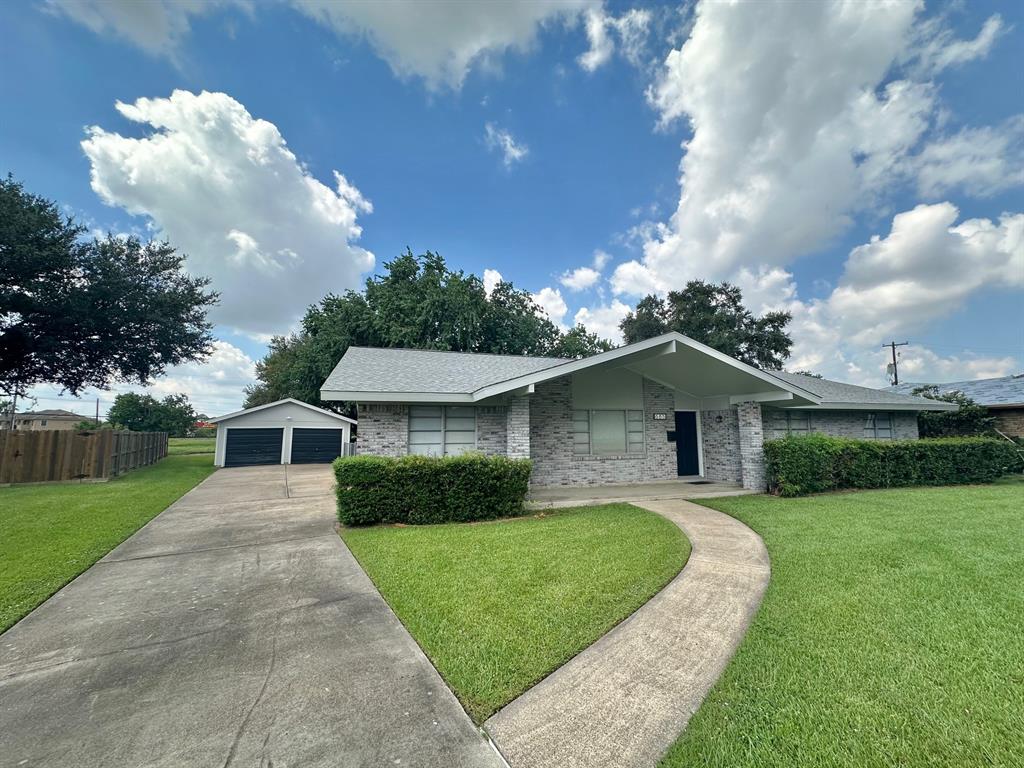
[662,479,1024,768]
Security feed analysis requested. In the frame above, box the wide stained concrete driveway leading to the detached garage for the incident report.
[0,466,504,768]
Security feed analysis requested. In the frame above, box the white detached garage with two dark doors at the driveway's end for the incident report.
[210,397,355,467]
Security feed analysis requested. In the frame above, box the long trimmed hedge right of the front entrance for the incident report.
[765,434,1021,496]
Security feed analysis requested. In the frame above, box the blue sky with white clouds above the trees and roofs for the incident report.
[0,0,1024,412]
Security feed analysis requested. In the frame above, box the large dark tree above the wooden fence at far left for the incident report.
[0,176,217,396]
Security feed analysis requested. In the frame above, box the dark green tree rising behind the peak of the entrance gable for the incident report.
[620,280,793,371]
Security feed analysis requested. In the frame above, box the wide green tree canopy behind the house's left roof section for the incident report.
[245,251,611,408]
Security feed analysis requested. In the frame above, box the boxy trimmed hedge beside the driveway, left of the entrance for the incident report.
[334,454,532,525]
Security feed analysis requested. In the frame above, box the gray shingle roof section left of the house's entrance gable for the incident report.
[323,347,568,394]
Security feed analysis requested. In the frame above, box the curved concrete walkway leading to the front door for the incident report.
[484,500,770,768]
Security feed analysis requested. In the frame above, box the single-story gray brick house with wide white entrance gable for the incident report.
[321,333,956,490]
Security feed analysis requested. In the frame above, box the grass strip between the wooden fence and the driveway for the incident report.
[0,456,213,632]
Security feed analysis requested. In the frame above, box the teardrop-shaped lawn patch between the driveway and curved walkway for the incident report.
[341,504,689,723]
